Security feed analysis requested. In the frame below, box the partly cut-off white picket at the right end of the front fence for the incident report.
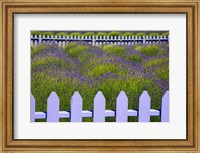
[161,91,169,122]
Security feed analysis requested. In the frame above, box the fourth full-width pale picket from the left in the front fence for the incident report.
[116,91,128,122]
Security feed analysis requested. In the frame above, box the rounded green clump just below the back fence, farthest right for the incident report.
[142,45,159,56]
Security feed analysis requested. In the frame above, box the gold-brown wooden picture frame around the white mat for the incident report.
[0,0,200,153]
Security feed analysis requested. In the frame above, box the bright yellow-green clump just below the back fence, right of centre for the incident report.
[103,45,125,56]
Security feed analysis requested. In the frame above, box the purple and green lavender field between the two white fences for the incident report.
[31,39,169,122]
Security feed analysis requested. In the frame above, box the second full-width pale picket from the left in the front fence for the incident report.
[70,91,83,122]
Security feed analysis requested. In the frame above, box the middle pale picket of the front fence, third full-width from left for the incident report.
[93,91,106,122]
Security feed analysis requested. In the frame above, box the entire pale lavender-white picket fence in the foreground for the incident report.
[30,91,169,122]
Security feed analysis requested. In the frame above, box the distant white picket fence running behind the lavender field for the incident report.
[31,35,169,48]
